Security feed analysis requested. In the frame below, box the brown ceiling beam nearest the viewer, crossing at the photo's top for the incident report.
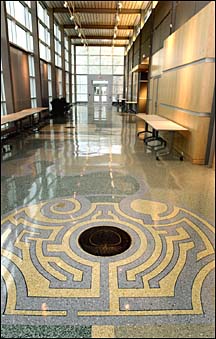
[53,7,141,14]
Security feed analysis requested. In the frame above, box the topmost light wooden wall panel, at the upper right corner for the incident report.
[163,1,215,70]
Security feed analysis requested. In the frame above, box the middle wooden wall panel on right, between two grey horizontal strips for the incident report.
[159,62,215,114]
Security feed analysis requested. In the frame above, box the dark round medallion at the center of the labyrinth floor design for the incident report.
[79,226,131,257]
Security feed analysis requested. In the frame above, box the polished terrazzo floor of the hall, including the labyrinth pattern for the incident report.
[1,105,215,338]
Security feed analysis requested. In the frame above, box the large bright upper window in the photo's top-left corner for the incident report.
[6,1,33,52]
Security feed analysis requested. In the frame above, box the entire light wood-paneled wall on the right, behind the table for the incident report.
[154,1,215,164]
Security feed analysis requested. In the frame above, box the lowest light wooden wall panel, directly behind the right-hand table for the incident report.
[158,105,210,164]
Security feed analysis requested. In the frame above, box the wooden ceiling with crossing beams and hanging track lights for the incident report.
[42,1,150,46]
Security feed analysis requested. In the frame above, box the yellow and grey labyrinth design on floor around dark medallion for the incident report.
[2,195,214,325]
